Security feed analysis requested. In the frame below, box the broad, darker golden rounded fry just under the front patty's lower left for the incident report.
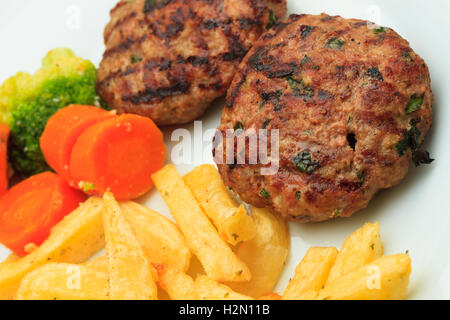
[227,208,290,298]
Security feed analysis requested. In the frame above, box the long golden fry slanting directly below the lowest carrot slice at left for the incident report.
[0,197,105,300]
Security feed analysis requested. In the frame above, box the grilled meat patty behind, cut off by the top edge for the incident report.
[97,0,286,126]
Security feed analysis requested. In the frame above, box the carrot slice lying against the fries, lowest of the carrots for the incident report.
[0,172,85,256]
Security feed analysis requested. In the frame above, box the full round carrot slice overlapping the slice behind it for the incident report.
[69,114,166,200]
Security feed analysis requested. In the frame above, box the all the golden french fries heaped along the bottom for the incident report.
[0,165,411,300]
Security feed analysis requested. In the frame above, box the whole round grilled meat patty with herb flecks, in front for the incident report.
[215,15,433,223]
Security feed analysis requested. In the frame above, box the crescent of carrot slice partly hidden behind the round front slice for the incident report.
[40,105,114,181]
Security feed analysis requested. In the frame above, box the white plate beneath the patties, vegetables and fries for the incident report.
[0,0,450,299]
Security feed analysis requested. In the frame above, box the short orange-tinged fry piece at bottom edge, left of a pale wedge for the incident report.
[153,264,198,300]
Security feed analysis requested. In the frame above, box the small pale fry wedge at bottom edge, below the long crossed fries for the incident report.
[195,276,253,300]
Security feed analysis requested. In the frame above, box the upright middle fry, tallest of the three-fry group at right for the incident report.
[325,222,383,287]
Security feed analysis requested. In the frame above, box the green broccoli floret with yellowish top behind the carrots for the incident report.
[0,49,106,177]
